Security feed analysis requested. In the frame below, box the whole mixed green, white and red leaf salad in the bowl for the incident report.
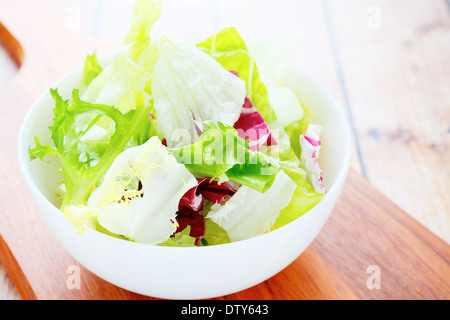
[29,0,326,247]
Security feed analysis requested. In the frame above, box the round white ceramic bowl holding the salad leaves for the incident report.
[18,59,351,299]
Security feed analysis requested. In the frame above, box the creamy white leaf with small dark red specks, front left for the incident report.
[65,137,197,244]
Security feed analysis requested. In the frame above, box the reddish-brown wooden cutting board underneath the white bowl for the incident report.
[0,0,450,300]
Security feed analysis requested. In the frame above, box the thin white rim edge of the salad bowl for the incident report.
[17,53,352,252]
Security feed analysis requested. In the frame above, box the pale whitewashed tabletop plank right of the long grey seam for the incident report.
[328,0,450,243]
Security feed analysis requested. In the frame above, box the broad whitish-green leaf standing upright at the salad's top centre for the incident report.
[151,44,246,147]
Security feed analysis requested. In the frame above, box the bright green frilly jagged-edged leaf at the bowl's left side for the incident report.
[29,89,153,208]
